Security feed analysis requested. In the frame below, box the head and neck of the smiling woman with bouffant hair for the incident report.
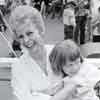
[9,6,46,67]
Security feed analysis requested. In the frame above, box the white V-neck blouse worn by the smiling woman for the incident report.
[12,51,50,100]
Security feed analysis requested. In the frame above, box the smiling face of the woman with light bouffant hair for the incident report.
[16,23,41,49]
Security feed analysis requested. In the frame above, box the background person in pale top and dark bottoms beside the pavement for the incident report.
[63,2,76,39]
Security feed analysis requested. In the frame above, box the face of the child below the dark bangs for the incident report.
[63,58,80,76]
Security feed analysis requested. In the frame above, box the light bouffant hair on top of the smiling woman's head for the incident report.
[9,5,45,38]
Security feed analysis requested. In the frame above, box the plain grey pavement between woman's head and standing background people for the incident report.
[44,18,64,44]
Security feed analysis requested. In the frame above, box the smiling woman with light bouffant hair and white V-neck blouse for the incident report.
[9,6,49,100]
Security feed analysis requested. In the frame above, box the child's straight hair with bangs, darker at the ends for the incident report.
[49,39,81,75]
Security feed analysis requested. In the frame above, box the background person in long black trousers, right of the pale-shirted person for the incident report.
[74,0,88,44]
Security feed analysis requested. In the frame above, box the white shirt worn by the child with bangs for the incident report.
[63,62,100,100]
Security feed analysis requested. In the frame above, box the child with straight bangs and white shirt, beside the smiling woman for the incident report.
[49,39,100,100]
